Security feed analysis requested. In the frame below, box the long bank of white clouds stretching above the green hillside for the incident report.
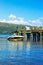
[0,14,43,26]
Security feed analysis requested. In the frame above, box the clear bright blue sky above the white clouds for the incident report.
[0,0,43,26]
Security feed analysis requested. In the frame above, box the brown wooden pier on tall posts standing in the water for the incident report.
[18,29,43,42]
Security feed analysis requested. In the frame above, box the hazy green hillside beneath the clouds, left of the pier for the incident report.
[0,22,25,34]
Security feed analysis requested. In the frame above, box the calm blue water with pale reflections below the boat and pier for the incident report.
[0,38,43,65]
